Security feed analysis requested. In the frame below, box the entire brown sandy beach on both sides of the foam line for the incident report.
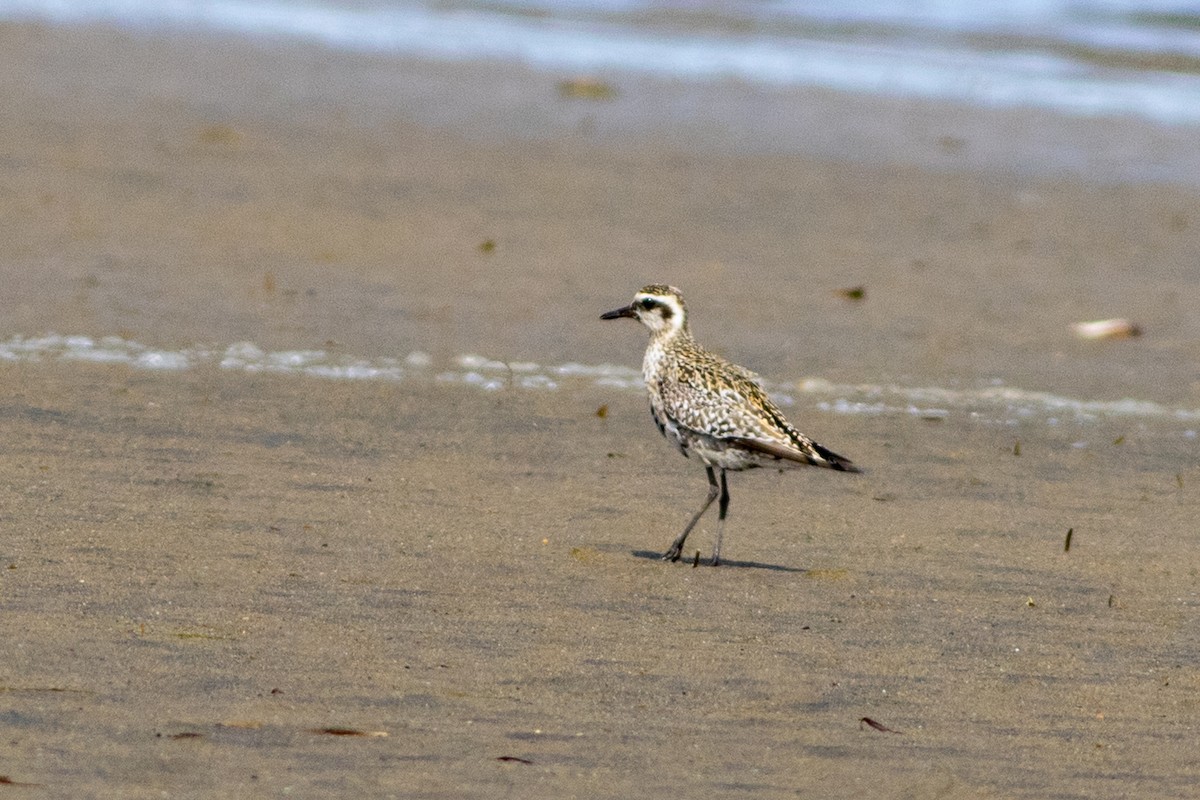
[0,18,1200,798]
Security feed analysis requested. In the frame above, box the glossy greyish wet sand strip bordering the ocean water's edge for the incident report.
[7,22,1200,193]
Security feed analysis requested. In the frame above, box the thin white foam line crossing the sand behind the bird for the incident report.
[0,333,1200,429]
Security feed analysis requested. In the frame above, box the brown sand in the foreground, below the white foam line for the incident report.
[2,367,1200,798]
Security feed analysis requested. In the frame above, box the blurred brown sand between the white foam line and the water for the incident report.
[7,25,1200,407]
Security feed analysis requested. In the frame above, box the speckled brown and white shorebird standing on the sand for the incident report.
[600,283,862,566]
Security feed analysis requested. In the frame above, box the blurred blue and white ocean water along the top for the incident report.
[7,0,1200,126]
